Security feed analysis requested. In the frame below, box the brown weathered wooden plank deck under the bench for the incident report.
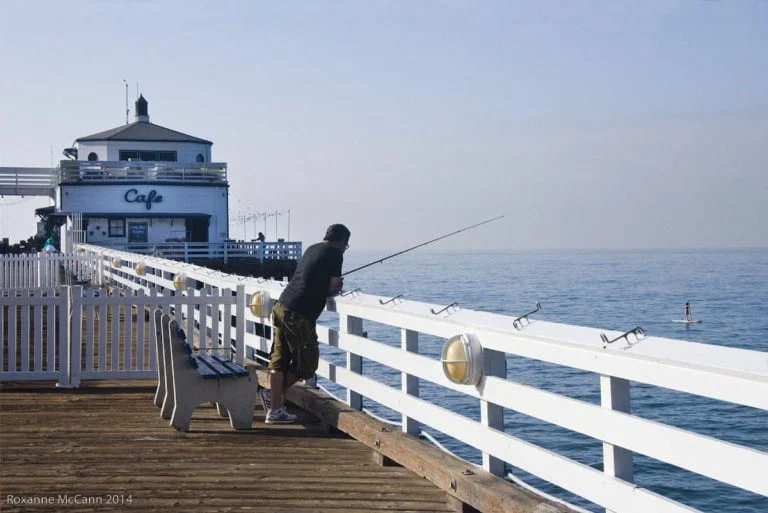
[0,381,451,513]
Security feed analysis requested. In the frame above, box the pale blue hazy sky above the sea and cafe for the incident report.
[0,0,768,250]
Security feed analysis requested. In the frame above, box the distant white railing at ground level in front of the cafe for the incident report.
[90,241,302,263]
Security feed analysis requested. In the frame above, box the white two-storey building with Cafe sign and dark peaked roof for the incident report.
[55,96,228,251]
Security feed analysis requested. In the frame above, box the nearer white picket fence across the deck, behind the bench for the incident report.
[0,282,245,387]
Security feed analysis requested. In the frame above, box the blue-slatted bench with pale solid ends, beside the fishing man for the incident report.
[155,313,258,431]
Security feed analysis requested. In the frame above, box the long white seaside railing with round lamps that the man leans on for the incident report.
[31,246,768,513]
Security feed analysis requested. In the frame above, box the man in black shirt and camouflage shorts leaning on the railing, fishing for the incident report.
[259,224,350,424]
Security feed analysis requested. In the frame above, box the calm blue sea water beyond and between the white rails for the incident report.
[321,249,768,513]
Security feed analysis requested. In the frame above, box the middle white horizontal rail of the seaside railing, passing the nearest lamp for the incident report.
[338,333,768,495]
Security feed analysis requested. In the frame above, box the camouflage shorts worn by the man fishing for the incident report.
[269,302,320,379]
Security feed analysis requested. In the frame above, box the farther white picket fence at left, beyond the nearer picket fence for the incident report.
[0,253,99,288]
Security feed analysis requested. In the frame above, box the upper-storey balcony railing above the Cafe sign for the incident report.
[59,160,227,183]
